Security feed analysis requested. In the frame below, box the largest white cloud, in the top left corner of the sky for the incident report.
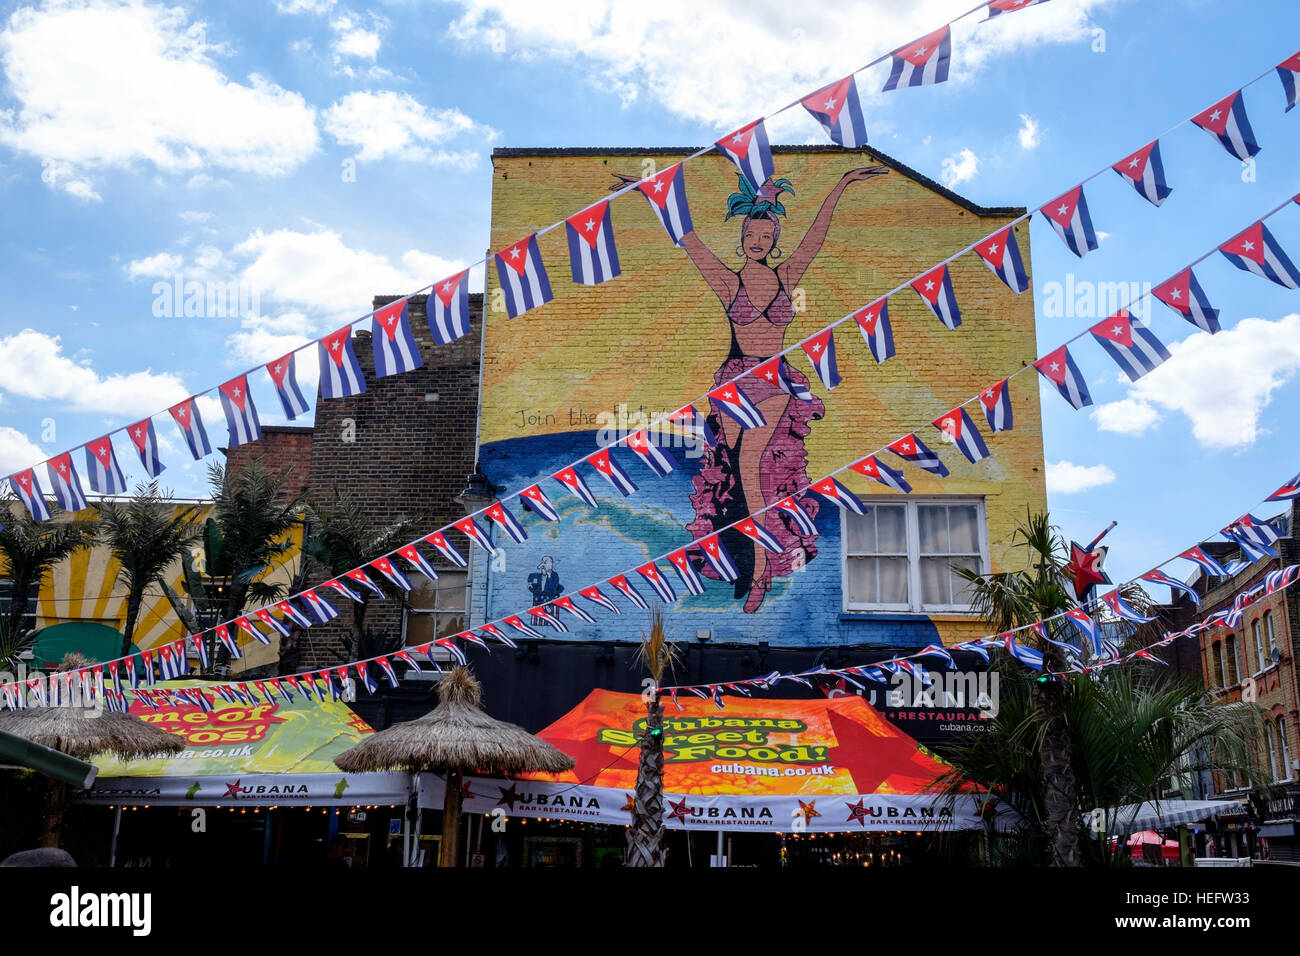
[0,0,319,200]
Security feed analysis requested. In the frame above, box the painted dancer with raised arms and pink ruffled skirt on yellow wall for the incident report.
[683,165,889,614]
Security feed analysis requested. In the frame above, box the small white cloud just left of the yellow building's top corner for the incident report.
[324,90,497,168]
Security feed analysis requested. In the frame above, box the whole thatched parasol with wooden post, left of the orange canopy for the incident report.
[334,667,573,866]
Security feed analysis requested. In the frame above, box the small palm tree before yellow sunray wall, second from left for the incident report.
[99,479,200,657]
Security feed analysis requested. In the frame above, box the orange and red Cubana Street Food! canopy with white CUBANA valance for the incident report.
[420,689,1018,832]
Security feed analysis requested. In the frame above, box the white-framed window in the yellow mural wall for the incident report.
[840,497,989,614]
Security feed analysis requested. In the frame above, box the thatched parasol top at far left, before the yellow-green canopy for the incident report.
[0,708,185,760]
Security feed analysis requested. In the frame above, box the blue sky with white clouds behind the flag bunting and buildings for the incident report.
[0,0,1300,595]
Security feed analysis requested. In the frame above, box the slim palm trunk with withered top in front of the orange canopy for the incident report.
[625,605,677,866]
